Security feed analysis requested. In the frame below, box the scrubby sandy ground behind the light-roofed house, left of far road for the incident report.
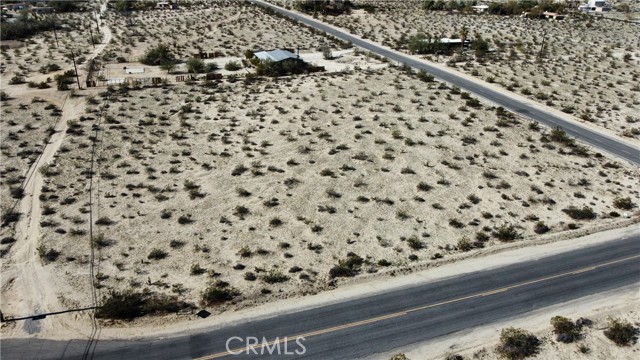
[103,1,344,62]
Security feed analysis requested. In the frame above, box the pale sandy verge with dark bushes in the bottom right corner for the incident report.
[376,285,640,360]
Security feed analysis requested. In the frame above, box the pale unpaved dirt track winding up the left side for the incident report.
[0,0,111,334]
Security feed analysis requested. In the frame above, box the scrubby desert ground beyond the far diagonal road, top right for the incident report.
[274,1,640,139]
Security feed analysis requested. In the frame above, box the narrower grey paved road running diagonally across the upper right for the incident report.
[249,0,640,165]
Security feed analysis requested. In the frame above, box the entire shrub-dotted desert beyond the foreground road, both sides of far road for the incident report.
[0,1,640,358]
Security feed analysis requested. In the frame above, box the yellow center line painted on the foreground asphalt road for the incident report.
[194,255,640,360]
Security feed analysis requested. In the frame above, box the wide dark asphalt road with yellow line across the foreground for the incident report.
[0,235,640,360]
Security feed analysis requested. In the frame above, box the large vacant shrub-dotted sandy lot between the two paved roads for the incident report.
[41,68,638,316]
